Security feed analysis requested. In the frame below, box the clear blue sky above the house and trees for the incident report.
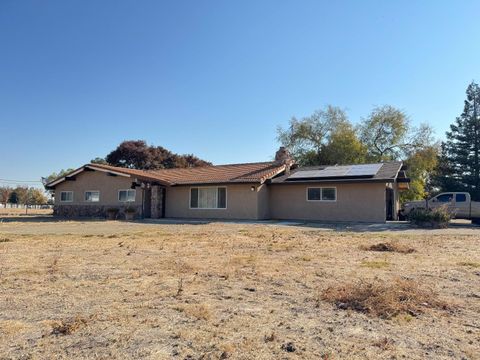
[0,0,480,188]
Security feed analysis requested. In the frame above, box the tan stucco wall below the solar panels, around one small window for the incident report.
[269,183,386,222]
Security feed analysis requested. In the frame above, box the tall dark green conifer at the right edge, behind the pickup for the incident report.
[435,82,480,201]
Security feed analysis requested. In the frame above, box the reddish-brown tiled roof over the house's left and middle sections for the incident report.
[47,162,285,187]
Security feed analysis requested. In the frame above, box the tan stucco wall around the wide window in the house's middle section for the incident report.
[165,184,258,219]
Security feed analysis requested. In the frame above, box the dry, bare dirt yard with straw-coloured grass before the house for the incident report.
[0,217,480,359]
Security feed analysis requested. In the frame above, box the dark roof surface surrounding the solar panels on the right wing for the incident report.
[271,161,403,184]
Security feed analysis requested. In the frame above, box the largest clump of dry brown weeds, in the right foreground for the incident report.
[321,279,452,319]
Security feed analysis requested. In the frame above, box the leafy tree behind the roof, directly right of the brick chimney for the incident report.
[277,105,366,166]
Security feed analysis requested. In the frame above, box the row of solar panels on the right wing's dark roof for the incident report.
[288,164,382,180]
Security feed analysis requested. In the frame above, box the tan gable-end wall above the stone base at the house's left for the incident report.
[55,171,142,206]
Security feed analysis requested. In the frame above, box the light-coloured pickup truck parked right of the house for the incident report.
[400,192,480,224]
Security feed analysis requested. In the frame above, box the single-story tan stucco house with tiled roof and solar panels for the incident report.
[47,148,409,222]
